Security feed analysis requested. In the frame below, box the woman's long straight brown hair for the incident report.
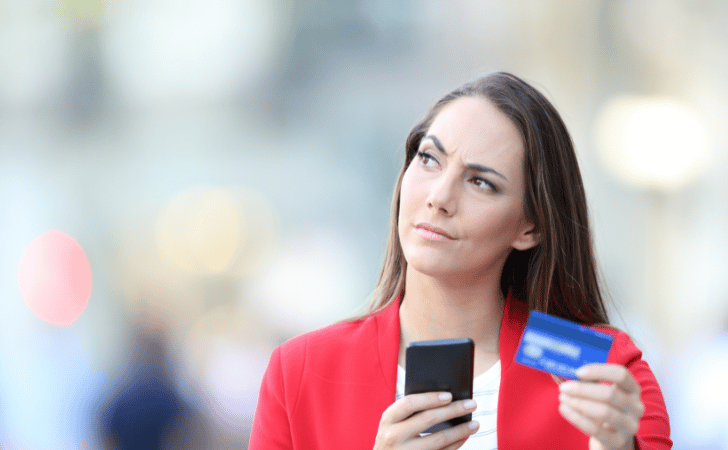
[367,72,608,324]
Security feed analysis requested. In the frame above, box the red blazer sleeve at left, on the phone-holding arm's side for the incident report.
[248,347,293,450]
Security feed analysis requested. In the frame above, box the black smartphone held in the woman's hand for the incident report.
[404,338,475,433]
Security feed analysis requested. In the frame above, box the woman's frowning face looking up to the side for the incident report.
[398,97,538,281]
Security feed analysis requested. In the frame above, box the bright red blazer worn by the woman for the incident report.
[249,299,672,450]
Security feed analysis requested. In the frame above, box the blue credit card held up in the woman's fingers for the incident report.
[516,311,614,379]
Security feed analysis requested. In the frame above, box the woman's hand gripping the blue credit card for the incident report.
[559,364,645,450]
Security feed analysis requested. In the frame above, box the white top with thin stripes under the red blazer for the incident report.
[397,360,500,450]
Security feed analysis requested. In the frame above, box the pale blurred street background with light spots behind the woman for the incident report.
[0,0,728,450]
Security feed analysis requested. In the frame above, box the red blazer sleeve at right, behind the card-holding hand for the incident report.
[608,332,672,450]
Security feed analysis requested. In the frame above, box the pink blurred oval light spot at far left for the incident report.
[18,230,91,325]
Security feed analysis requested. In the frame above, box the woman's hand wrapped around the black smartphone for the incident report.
[374,392,480,450]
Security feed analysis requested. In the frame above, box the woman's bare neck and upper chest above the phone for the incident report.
[399,267,505,372]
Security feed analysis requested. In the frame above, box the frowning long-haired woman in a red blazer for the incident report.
[250,73,672,450]
